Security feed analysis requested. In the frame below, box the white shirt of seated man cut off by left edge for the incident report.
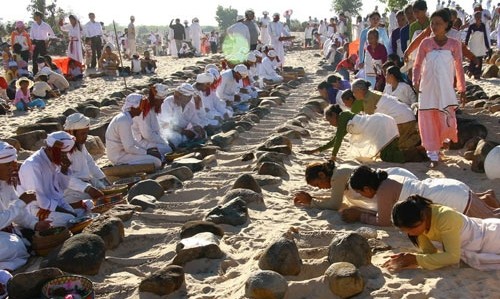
[0,181,38,229]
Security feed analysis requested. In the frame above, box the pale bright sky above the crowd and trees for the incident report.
[0,0,484,26]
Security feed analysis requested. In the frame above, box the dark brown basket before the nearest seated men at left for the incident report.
[31,226,71,256]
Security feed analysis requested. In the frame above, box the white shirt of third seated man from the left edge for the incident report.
[68,144,106,192]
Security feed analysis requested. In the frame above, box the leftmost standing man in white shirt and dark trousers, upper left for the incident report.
[30,11,55,74]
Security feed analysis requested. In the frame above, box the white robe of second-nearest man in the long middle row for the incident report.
[132,108,172,156]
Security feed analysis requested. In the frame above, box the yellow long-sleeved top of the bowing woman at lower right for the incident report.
[416,205,463,270]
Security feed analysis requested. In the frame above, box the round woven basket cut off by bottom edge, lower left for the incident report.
[42,275,94,299]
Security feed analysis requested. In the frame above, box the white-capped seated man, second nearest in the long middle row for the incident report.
[132,83,172,161]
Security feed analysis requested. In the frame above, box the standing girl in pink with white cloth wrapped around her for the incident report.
[413,9,465,168]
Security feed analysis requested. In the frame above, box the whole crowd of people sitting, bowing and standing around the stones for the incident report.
[0,0,500,296]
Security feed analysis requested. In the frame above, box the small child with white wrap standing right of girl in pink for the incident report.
[465,11,490,79]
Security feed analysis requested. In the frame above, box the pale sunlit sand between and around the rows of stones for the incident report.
[5,45,500,299]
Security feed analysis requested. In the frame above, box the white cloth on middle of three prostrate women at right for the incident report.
[399,178,471,213]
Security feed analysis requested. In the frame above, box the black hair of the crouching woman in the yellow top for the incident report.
[392,194,432,246]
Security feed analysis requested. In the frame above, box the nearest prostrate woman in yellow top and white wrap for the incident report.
[383,195,500,271]
